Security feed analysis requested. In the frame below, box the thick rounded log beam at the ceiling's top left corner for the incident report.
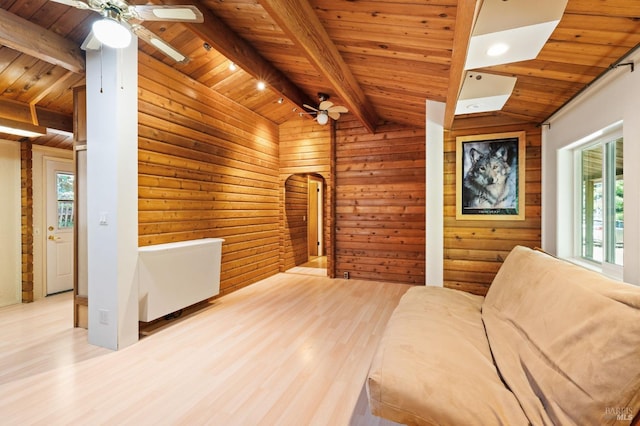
[0,9,85,74]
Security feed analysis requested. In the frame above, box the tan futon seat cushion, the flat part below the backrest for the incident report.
[367,286,527,425]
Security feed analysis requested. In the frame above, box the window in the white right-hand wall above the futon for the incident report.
[574,129,624,271]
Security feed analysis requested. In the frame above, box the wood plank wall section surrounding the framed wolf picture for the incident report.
[444,126,541,295]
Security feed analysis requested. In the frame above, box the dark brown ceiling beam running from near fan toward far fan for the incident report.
[156,0,314,114]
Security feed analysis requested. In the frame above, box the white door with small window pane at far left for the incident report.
[46,160,75,295]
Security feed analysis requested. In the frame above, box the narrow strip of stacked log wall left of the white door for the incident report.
[20,140,33,303]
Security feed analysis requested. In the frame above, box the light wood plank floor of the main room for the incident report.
[0,274,409,426]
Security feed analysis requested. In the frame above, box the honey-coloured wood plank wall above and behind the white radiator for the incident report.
[138,54,279,294]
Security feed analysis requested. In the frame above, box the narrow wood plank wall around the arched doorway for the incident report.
[280,118,334,277]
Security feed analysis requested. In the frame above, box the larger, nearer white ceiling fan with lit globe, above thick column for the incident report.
[51,0,204,63]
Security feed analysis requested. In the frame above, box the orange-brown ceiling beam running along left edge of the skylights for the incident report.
[444,0,482,130]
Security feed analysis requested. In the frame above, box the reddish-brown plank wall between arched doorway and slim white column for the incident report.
[335,116,425,284]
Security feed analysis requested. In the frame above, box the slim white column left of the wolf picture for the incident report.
[425,101,445,287]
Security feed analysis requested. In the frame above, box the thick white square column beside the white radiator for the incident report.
[86,37,138,350]
